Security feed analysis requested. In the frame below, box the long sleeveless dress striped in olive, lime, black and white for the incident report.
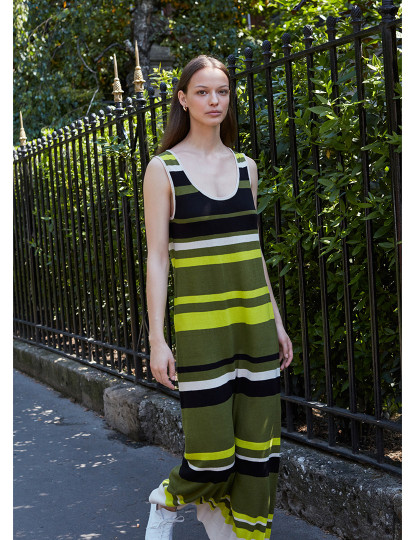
[149,150,281,540]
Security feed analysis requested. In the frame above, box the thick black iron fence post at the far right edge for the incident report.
[379,0,402,351]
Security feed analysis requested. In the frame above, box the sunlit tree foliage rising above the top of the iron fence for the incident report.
[13,0,400,144]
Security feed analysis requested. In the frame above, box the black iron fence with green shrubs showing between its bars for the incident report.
[13,1,401,474]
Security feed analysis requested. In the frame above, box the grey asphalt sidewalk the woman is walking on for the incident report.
[13,370,337,540]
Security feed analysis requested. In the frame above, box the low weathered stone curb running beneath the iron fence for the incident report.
[13,339,402,540]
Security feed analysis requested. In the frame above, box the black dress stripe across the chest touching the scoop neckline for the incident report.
[173,188,255,221]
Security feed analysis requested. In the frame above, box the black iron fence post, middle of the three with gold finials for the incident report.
[113,54,138,374]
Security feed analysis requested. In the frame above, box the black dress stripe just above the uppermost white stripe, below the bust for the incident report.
[169,214,258,241]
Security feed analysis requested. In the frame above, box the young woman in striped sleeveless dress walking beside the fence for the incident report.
[144,56,293,540]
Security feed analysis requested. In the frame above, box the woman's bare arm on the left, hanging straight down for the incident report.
[143,159,175,390]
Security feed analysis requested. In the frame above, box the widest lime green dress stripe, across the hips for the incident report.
[174,302,274,334]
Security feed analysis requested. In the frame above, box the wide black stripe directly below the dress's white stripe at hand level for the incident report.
[180,377,280,409]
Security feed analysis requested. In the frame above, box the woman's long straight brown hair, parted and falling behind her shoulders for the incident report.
[156,54,236,154]
